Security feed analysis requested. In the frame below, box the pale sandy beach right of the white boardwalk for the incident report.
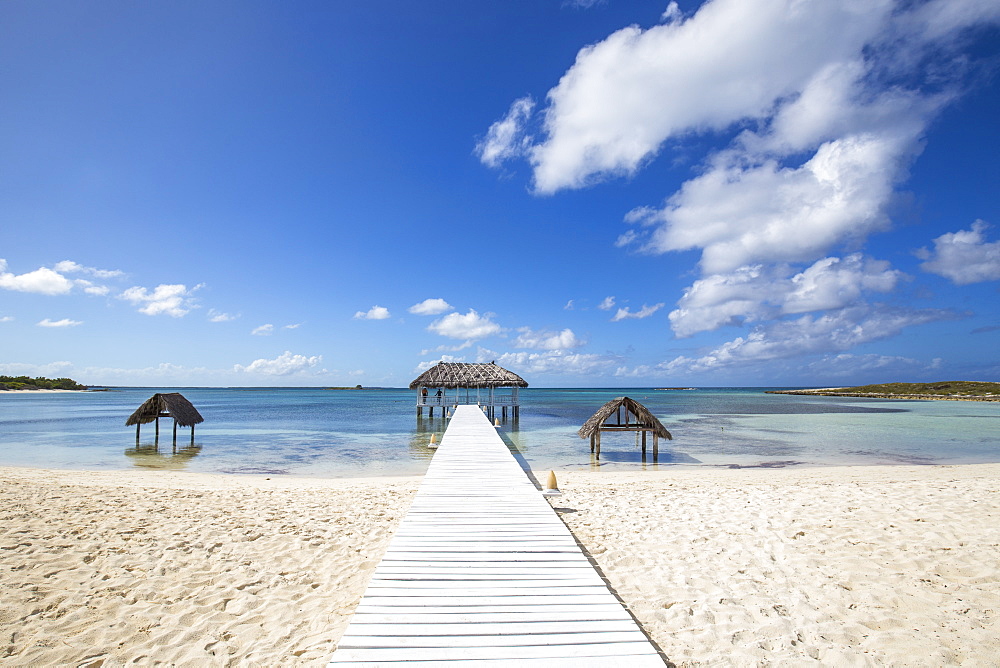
[554,464,1000,666]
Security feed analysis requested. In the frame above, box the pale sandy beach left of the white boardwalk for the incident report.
[0,468,419,666]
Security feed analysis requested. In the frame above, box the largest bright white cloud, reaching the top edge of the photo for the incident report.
[531,0,893,193]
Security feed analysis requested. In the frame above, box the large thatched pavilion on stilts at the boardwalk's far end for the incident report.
[410,362,528,419]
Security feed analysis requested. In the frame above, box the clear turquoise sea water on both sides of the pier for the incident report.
[0,388,1000,477]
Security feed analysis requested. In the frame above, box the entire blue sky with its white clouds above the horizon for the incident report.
[0,0,1000,387]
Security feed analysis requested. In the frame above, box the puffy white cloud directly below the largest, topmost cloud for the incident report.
[629,128,917,273]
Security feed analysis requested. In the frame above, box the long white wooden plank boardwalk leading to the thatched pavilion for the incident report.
[330,406,664,668]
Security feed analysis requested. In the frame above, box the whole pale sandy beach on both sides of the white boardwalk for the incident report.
[0,464,1000,666]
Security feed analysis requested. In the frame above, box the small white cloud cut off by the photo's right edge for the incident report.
[918,220,1000,285]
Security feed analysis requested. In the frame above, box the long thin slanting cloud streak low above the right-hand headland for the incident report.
[659,305,957,372]
